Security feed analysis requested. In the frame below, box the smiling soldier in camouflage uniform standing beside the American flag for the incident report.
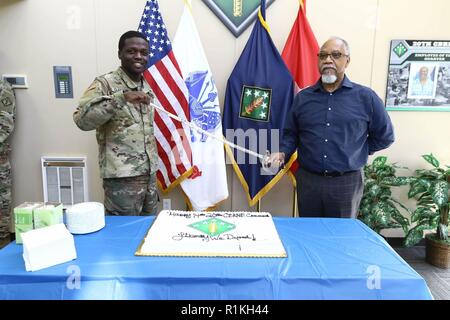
[73,31,158,215]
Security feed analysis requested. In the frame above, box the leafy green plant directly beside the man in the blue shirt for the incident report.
[358,156,410,234]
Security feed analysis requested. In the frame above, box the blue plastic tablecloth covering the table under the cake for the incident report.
[0,217,432,300]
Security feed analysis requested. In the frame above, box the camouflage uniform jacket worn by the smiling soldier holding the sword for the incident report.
[73,67,158,178]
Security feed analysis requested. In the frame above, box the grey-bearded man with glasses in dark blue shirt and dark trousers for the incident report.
[269,37,394,218]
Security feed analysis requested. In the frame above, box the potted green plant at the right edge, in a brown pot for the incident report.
[405,154,450,268]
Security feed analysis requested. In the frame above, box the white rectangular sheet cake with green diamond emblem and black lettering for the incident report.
[136,210,287,257]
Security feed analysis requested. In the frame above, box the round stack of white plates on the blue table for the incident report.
[66,202,105,234]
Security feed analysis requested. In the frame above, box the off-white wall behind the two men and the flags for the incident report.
[0,0,450,233]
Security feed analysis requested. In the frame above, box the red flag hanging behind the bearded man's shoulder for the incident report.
[281,0,320,180]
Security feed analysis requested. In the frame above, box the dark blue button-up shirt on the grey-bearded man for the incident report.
[280,77,394,172]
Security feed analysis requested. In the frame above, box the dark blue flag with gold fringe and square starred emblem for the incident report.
[223,0,294,206]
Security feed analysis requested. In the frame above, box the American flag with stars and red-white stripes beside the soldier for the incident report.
[138,0,192,191]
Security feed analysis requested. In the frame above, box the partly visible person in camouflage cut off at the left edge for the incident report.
[0,79,16,249]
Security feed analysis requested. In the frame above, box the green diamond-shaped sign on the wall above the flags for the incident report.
[203,0,275,38]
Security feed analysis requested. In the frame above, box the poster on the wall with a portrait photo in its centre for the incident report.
[386,40,450,111]
